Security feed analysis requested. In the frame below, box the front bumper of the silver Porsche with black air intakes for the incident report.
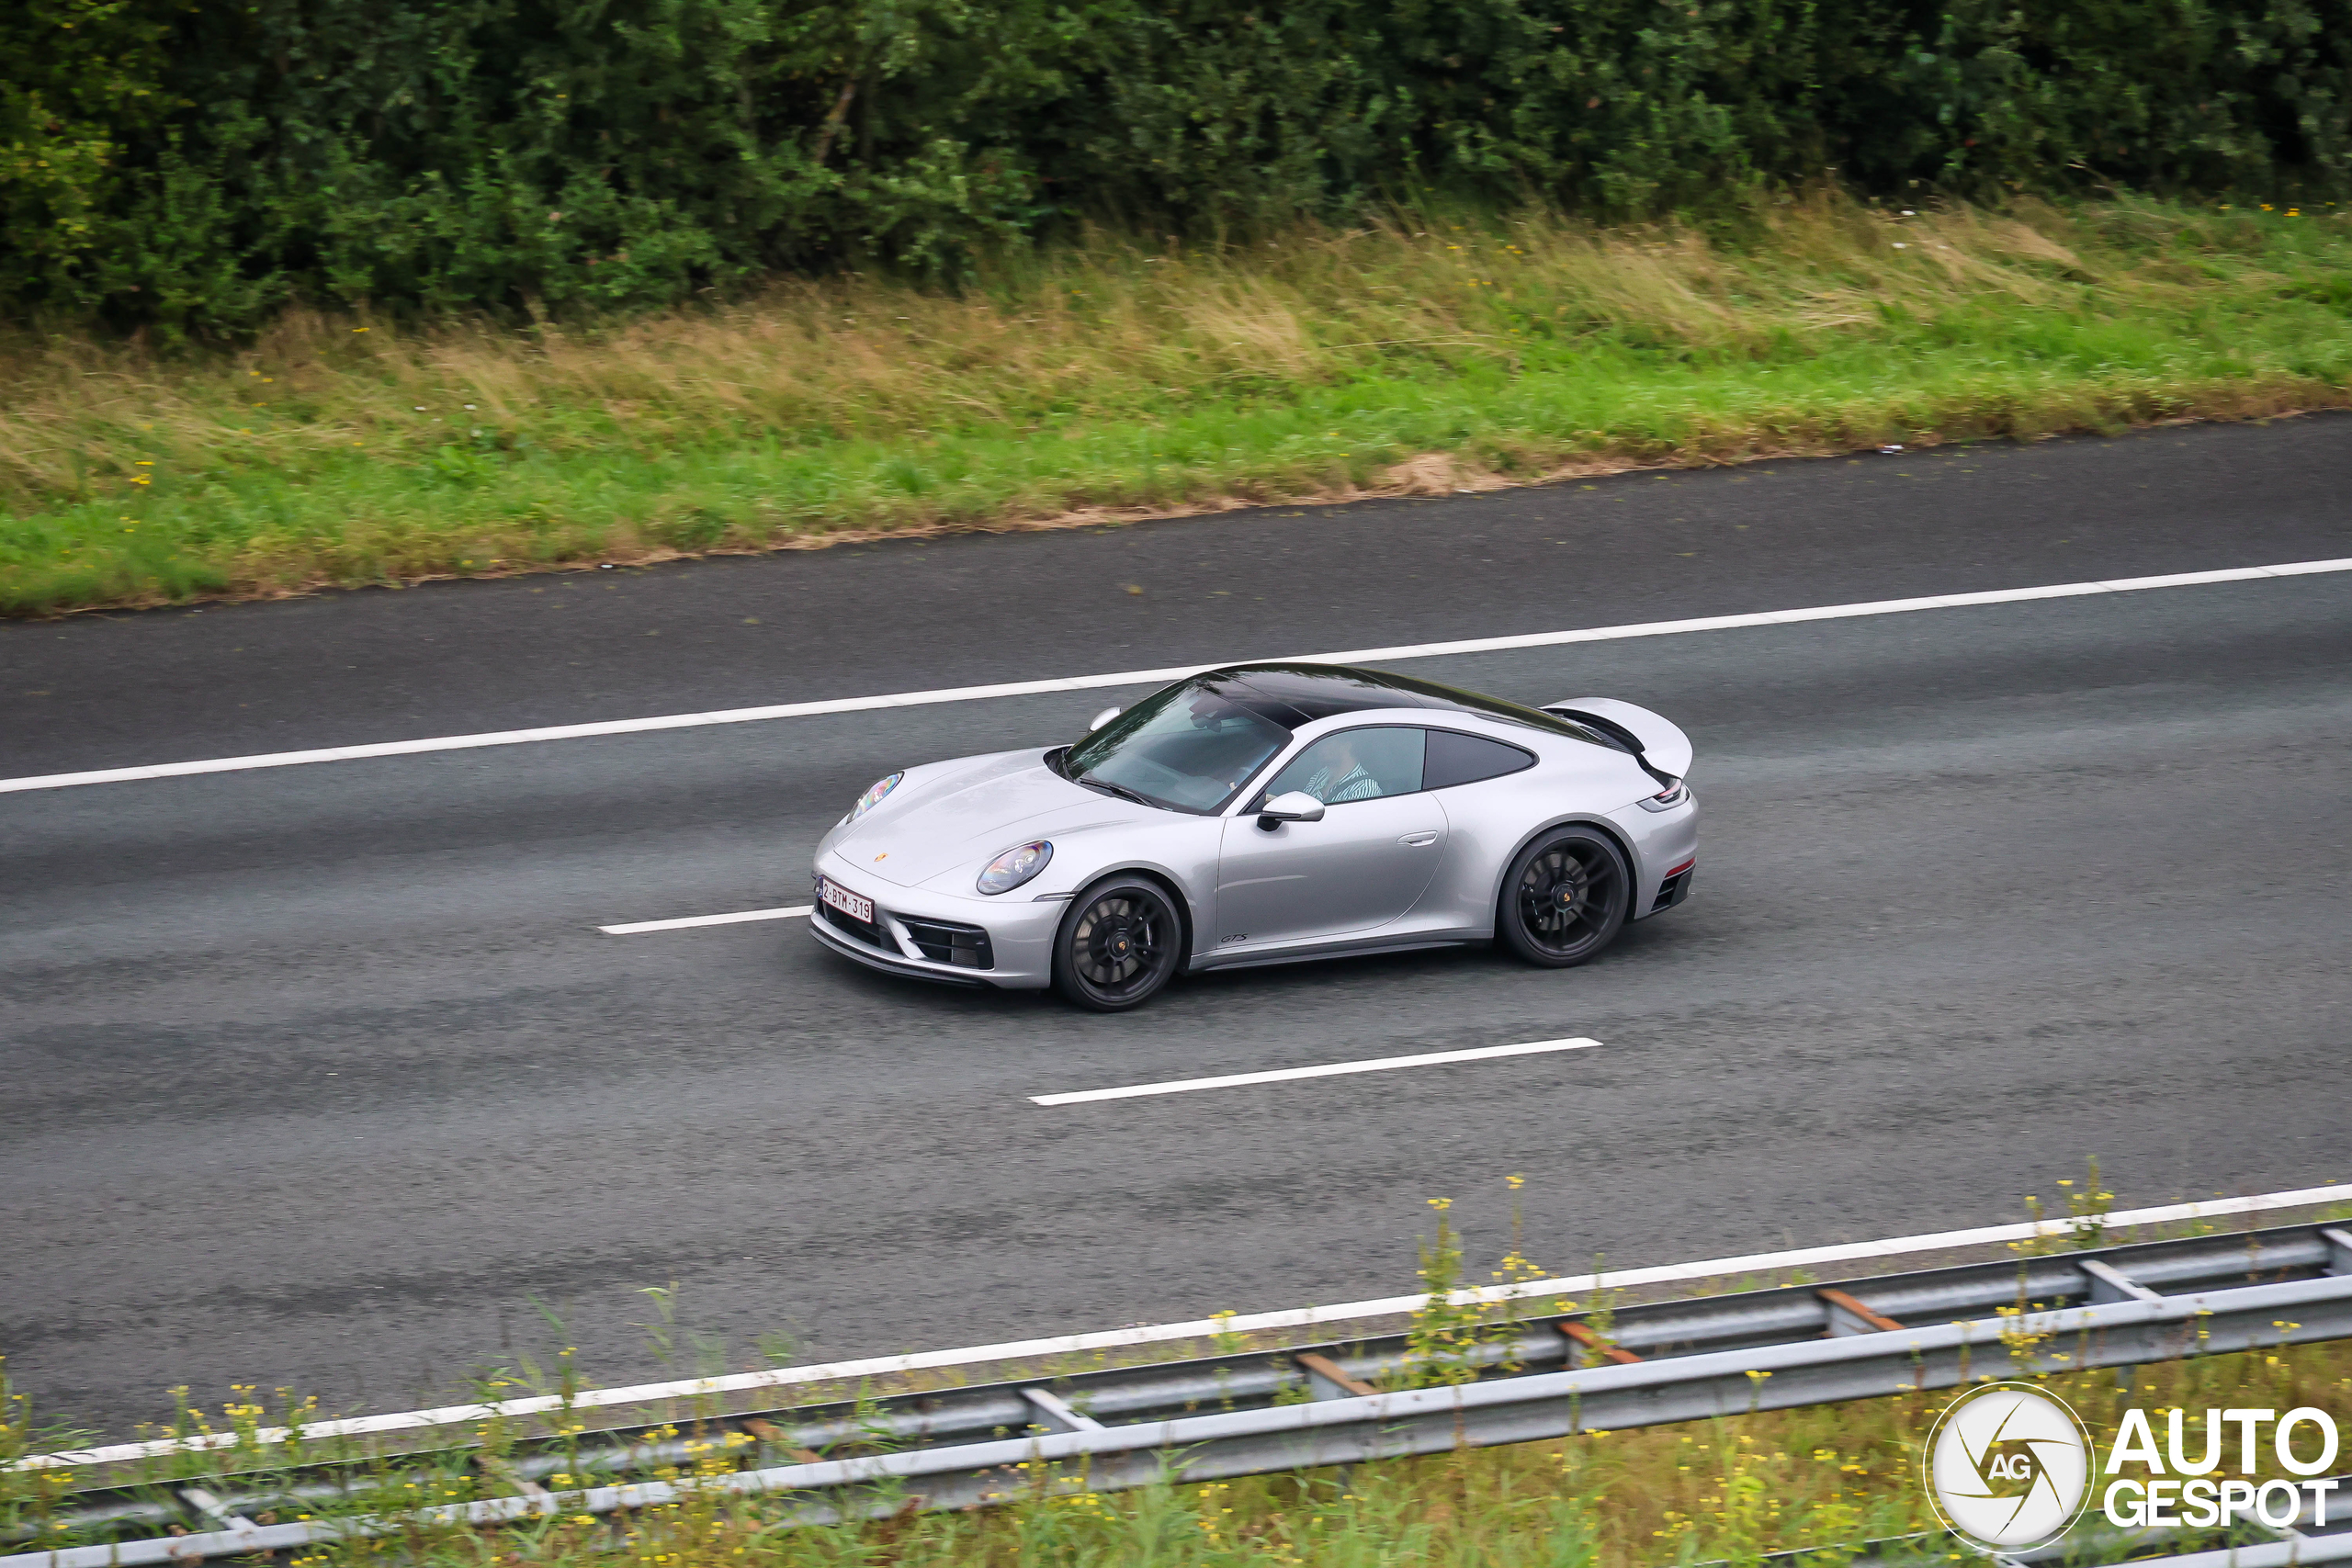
[809,853,1070,989]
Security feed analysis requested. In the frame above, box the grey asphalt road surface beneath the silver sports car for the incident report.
[0,419,2352,1429]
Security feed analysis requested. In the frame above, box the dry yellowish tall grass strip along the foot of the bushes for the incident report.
[0,200,2117,495]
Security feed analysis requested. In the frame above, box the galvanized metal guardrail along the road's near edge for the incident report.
[14,1224,2352,1568]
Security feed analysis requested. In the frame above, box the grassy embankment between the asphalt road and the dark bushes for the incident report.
[0,197,2352,614]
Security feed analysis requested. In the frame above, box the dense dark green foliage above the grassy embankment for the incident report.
[0,0,2352,332]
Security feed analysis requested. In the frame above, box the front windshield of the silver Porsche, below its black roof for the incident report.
[1063,677,1291,813]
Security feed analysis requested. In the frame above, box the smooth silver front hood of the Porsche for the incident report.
[832,750,1159,886]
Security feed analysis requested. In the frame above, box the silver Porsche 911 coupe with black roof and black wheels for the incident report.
[809,663,1698,1010]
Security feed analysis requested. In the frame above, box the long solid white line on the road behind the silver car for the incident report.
[0,558,2352,795]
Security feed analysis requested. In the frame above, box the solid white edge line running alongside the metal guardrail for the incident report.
[22,1185,2352,1470]
